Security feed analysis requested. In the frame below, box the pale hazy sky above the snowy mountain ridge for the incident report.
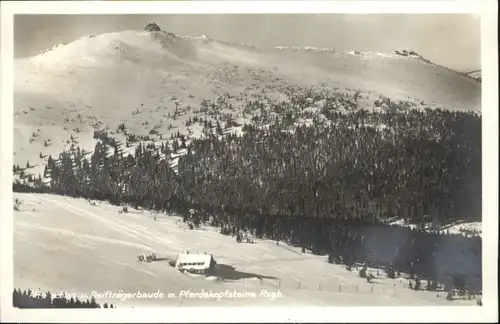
[14,14,481,71]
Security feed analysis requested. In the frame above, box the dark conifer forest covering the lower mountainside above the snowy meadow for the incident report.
[13,89,482,293]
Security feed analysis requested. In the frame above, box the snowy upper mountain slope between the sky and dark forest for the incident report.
[14,31,481,180]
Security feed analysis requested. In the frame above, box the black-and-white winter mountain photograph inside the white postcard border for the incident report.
[2,1,498,321]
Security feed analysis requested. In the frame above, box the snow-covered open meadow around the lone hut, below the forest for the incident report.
[14,193,476,307]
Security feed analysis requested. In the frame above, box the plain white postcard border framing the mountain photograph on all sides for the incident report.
[0,0,499,323]
